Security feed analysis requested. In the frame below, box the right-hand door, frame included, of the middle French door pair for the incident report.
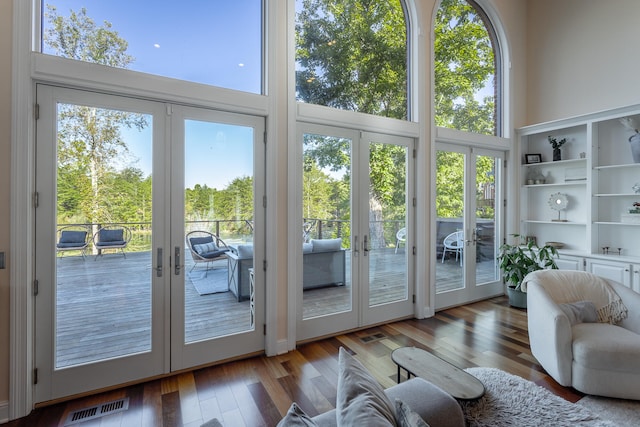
[360,133,413,324]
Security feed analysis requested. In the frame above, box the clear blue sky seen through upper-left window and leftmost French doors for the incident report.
[44,0,262,189]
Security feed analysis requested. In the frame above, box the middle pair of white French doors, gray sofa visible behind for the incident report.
[296,124,413,340]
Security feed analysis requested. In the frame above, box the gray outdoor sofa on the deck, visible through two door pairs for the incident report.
[227,239,346,301]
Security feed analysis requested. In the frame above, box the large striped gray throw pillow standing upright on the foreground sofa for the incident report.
[336,347,396,427]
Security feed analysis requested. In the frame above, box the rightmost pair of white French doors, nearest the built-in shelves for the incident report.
[433,143,503,308]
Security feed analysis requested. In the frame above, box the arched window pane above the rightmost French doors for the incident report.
[434,0,501,136]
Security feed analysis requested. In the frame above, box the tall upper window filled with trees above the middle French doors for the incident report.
[296,0,408,120]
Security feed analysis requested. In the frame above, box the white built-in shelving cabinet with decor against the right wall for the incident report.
[515,105,640,292]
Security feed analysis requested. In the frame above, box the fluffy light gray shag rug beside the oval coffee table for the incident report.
[460,368,618,427]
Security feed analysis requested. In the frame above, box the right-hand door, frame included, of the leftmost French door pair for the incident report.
[171,106,265,370]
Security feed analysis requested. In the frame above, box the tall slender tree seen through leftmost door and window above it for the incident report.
[44,5,150,237]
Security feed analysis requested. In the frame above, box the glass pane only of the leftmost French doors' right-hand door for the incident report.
[184,120,255,343]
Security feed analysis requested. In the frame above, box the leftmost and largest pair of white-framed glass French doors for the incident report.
[35,85,264,402]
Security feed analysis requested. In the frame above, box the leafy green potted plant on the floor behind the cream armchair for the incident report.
[498,234,558,308]
